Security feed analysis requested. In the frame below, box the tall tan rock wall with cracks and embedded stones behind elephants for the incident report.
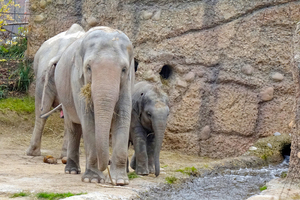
[28,0,300,157]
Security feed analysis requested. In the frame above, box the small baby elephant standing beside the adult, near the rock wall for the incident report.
[129,81,169,176]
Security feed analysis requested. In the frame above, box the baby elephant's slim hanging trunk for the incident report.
[153,119,166,176]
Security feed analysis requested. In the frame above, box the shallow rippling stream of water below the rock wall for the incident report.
[140,159,288,200]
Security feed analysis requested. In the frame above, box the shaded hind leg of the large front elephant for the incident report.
[65,114,82,174]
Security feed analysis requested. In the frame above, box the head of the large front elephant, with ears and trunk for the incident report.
[72,27,134,171]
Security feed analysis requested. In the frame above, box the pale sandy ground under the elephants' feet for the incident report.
[0,111,213,200]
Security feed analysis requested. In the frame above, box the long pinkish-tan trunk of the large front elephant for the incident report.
[91,67,120,171]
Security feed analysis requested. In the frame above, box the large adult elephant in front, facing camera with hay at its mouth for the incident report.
[55,27,134,185]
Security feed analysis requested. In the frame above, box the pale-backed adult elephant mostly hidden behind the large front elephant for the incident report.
[26,24,85,157]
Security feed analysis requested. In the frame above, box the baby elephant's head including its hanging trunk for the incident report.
[133,82,169,176]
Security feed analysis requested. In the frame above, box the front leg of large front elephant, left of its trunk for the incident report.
[81,111,105,183]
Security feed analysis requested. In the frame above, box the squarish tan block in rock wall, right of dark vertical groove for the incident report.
[212,85,258,136]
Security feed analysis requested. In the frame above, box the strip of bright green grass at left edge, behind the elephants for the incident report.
[0,97,35,113]
